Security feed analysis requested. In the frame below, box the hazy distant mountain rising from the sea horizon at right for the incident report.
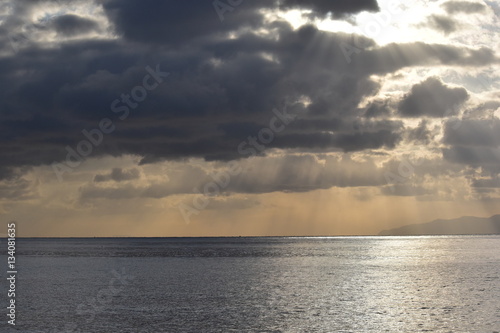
[379,215,500,236]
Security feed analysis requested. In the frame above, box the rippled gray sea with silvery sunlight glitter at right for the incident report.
[0,236,500,333]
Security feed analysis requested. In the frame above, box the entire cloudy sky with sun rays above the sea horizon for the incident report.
[0,0,500,237]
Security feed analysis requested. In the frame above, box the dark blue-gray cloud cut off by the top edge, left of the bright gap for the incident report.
[103,0,264,44]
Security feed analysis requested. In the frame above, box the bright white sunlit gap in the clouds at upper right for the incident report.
[279,0,500,48]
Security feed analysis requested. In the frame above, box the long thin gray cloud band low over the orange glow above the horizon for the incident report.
[80,153,480,198]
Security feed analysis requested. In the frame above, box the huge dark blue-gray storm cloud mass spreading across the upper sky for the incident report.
[0,1,498,176]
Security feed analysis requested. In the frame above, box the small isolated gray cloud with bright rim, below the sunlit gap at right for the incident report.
[399,77,469,118]
